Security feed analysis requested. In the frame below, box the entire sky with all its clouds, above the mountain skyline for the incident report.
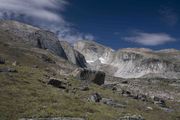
[0,0,180,49]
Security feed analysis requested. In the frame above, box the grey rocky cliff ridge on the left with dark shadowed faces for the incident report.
[0,21,86,67]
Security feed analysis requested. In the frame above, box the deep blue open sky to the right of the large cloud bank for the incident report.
[64,0,180,49]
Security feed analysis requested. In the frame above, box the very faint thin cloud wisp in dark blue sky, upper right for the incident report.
[158,6,179,26]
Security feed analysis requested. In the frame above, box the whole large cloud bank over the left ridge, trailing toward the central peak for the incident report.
[0,0,94,42]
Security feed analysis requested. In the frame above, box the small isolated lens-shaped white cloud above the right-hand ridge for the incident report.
[123,32,176,46]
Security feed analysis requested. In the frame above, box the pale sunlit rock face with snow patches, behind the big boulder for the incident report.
[74,41,180,79]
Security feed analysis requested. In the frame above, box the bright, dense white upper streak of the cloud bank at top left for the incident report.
[0,0,67,22]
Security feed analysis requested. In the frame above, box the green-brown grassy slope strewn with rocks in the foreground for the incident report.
[0,31,180,120]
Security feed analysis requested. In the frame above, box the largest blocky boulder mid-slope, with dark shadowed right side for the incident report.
[73,69,105,85]
